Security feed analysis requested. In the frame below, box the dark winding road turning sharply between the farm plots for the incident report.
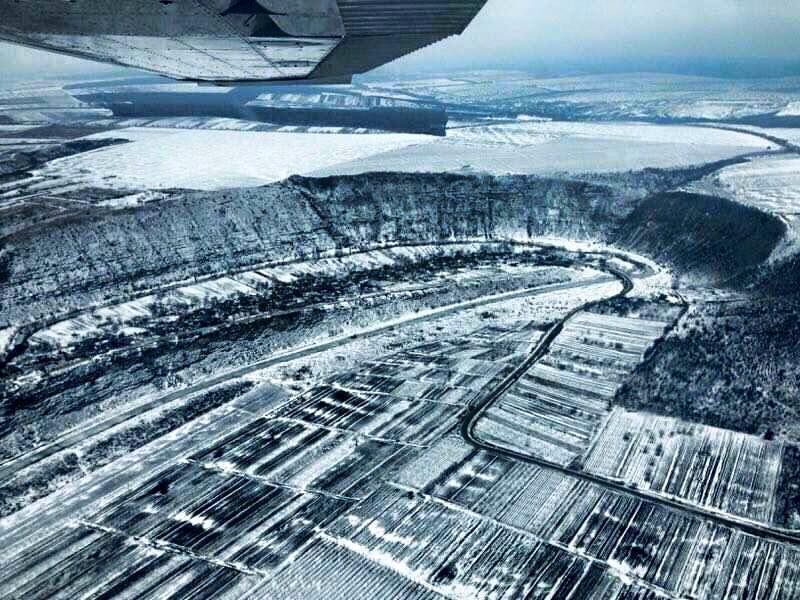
[461,267,800,544]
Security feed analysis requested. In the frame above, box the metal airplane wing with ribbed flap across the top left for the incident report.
[0,0,486,83]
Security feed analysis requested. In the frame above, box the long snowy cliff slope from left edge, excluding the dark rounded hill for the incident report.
[0,174,628,321]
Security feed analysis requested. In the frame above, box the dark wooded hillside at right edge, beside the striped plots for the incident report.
[617,247,800,442]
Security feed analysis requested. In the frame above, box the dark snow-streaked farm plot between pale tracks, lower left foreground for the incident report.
[87,463,353,574]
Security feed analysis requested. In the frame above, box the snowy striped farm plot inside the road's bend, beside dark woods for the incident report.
[475,311,667,465]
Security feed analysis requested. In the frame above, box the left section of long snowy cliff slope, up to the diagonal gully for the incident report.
[0,186,334,320]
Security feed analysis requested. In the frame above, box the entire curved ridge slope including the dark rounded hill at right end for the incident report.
[0,166,782,326]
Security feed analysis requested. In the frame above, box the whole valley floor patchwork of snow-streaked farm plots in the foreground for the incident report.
[0,246,800,599]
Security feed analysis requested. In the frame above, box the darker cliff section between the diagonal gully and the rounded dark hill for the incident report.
[290,173,624,245]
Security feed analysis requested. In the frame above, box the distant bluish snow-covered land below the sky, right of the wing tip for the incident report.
[370,71,798,121]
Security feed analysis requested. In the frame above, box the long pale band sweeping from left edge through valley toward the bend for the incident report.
[0,276,613,480]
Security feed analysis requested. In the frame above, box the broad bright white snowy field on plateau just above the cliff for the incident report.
[23,120,769,190]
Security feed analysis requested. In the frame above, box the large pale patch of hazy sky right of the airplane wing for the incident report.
[444,0,800,59]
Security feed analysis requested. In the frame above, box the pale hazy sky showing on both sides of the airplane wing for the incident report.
[0,0,800,77]
